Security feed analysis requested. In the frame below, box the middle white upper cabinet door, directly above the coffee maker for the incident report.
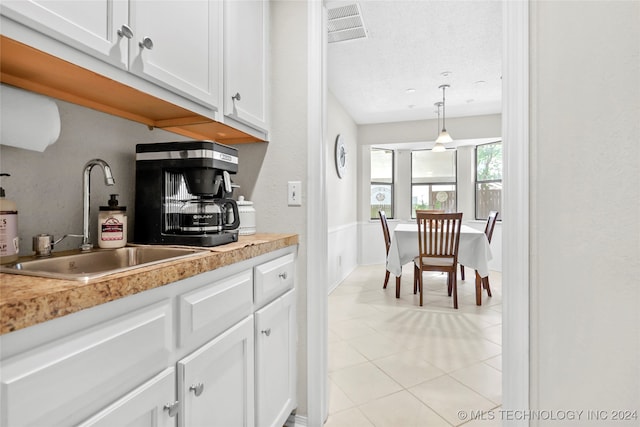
[129,0,222,109]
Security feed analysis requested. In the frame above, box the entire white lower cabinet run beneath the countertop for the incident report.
[0,247,296,427]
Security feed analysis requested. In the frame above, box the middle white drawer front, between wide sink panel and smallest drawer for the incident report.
[178,270,253,346]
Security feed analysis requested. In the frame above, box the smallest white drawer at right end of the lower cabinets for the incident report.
[254,254,295,308]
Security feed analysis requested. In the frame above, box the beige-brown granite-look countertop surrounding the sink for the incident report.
[0,233,298,334]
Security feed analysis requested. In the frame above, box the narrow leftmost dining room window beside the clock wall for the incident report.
[371,148,393,219]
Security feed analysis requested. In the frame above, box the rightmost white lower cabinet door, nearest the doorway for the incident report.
[254,290,296,427]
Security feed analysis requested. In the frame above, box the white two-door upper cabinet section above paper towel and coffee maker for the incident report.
[0,0,223,111]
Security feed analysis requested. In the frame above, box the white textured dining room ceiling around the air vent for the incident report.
[327,0,502,124]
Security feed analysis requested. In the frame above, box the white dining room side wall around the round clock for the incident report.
[326,92,358,292]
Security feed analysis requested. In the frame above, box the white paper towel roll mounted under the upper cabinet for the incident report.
[0,84,60,152]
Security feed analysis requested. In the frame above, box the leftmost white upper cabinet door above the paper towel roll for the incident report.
[0,0,129,68]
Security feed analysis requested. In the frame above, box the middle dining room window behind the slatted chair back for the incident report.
[411,150,457,218]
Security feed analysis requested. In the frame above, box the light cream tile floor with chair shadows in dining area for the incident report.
[325,264,502,427]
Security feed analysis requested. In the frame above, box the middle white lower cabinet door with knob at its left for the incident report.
[178,316,254,427]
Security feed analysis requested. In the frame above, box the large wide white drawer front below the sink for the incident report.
[0,300,172,426]
